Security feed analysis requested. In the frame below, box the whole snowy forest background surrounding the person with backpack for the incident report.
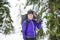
[0,0,60,40]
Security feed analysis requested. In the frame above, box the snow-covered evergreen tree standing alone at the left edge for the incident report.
[0,1,14,34]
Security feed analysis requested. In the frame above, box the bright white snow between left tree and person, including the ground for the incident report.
[0,0,23,40]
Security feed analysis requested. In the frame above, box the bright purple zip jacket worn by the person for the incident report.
[22,20,41,40]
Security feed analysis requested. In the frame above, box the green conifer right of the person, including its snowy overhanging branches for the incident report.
[26,0,60,40]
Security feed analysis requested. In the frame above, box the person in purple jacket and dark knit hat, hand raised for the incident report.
[22,10,41,40]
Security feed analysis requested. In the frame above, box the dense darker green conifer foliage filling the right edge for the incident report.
[47,0,60,40]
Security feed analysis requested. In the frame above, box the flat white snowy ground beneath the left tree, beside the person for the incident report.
[0,33,23,40]
